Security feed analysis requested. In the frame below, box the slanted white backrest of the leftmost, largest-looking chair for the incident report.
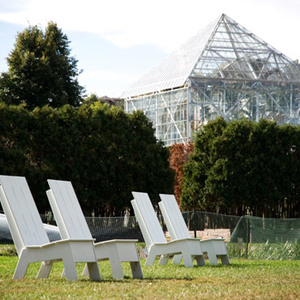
[0,175,49,254]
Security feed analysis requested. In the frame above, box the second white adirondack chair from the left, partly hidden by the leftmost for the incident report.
[47,179,143,279]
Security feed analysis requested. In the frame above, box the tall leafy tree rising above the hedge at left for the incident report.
[0,22,83,109]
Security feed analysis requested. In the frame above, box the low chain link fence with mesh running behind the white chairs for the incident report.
[0,211,300,259]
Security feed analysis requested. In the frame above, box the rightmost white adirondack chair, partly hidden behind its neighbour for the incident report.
[158,194,229,265]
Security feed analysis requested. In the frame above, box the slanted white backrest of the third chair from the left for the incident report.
[131,192,167,247]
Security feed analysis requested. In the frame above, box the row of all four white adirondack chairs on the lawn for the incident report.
[0,175,229,281]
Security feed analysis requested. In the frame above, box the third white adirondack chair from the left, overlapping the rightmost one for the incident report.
[131,192,205,267]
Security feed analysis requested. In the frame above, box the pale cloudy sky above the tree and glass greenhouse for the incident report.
[0,0,300,97]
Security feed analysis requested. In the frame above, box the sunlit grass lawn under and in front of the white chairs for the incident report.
[0,252,300,299]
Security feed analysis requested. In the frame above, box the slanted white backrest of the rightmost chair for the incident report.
[158,194,191,240]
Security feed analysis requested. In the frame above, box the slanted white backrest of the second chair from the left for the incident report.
[47,179,92,240]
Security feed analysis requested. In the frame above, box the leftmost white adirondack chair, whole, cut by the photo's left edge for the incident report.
[0,176,100,280]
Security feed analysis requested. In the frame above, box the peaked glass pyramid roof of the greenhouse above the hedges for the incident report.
[122,14,300,98]
